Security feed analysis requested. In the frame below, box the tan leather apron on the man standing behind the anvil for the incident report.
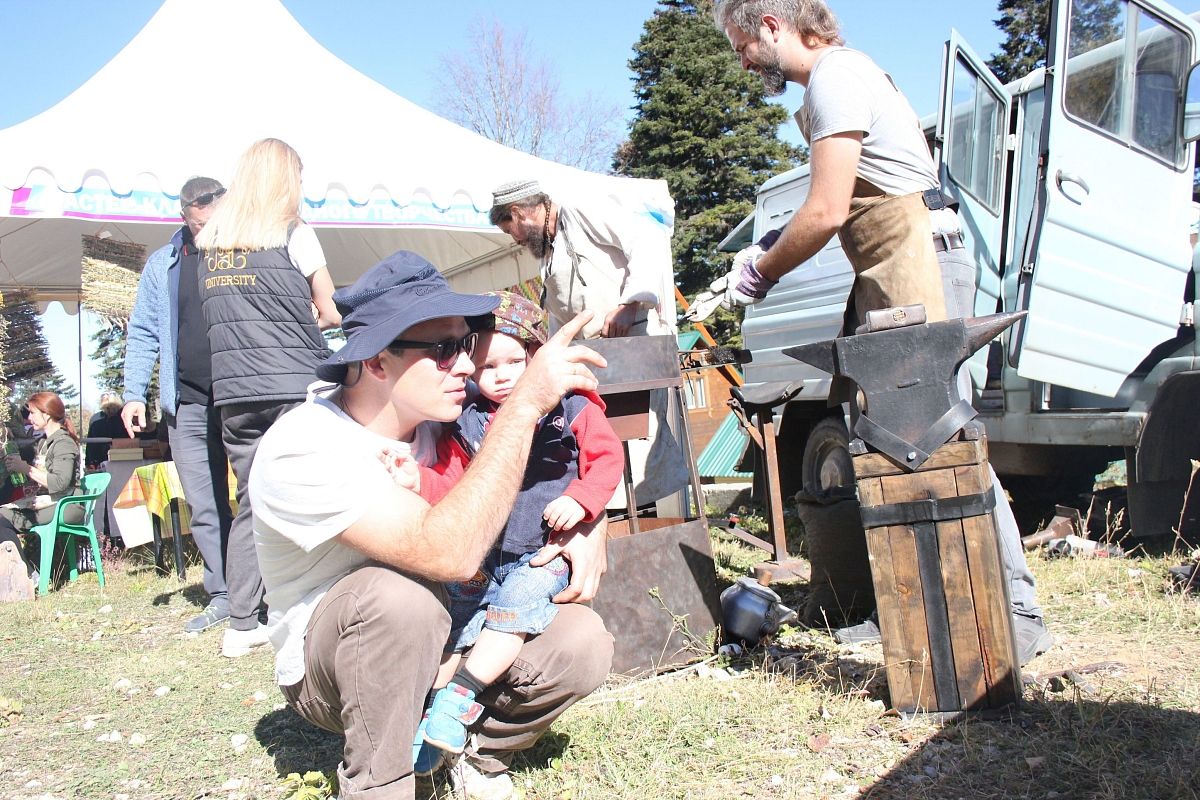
[829,178,947,405]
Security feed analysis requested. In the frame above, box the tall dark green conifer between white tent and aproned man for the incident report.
[613,0,802,319]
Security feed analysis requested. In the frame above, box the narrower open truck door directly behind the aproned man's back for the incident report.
[935,30,1010,321]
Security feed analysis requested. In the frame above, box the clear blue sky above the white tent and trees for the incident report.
[0,0,1200,404]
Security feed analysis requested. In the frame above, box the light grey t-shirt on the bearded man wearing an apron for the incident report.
[796,47,938,194]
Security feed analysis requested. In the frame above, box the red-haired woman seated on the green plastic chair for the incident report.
[0,392,83,572]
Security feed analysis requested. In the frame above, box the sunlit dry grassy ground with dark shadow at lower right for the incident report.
[0,532,1200,800]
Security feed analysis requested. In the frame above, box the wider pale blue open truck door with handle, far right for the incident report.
[1013,0,1196,397]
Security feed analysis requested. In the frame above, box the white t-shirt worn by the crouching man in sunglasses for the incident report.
[250,383,437,686]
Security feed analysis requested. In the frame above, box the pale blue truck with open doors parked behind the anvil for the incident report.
[726,0,1200,536]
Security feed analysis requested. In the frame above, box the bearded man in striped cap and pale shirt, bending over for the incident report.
[488,179,689,507]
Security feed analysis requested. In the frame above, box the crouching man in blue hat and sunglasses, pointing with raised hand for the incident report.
[250,252,612,800]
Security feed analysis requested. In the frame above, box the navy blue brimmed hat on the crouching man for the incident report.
[317,249,500,383]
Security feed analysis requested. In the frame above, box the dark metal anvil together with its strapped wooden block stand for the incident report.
[784,309,1024,714]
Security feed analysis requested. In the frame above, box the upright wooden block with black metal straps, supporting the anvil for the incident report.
[853,428,1020,712]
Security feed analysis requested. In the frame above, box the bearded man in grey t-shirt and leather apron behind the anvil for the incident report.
[714,0,1052,664]
